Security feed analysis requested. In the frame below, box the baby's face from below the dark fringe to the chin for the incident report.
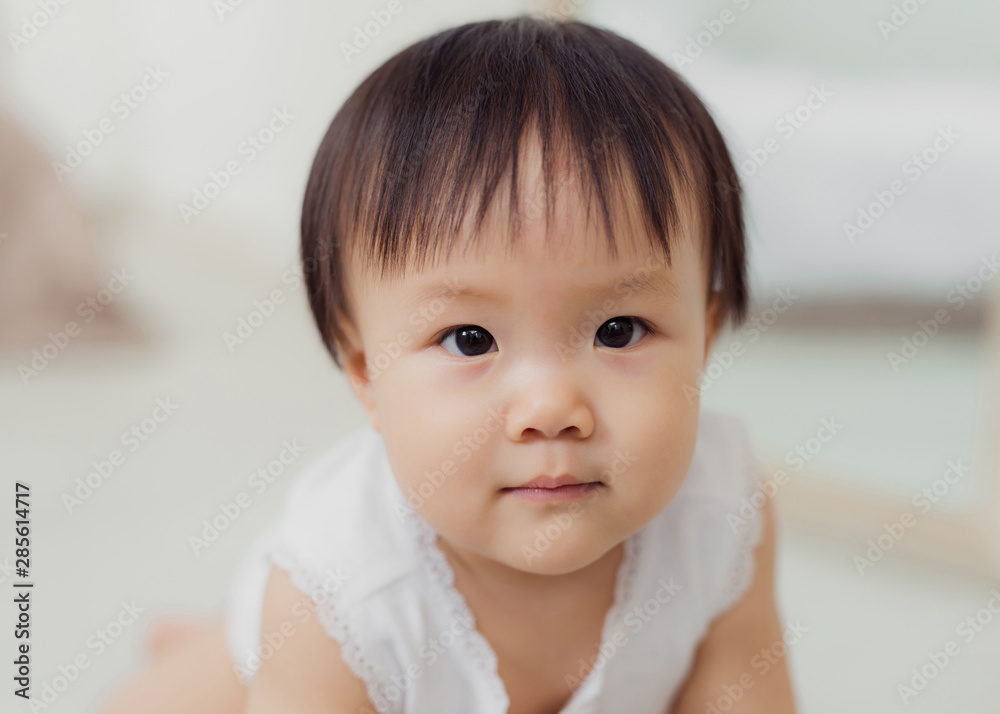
[345,175,714,574]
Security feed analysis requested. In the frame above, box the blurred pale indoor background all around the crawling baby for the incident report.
[0,0,1000,714]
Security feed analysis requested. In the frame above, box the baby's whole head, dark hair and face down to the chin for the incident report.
[302,16,747,574]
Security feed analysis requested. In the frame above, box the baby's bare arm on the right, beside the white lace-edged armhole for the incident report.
[672,501,795,714]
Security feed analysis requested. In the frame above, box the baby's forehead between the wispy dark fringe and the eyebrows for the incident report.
[340,118,711,318]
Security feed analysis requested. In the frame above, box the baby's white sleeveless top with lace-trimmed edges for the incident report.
[226,408,761,714]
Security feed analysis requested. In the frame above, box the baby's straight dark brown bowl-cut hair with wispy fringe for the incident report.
[301,15,748,368]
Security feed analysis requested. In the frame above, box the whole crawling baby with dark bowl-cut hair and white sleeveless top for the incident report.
[97,11,794,714]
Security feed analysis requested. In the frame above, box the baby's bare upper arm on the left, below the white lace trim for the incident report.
[246,568,375,714]
